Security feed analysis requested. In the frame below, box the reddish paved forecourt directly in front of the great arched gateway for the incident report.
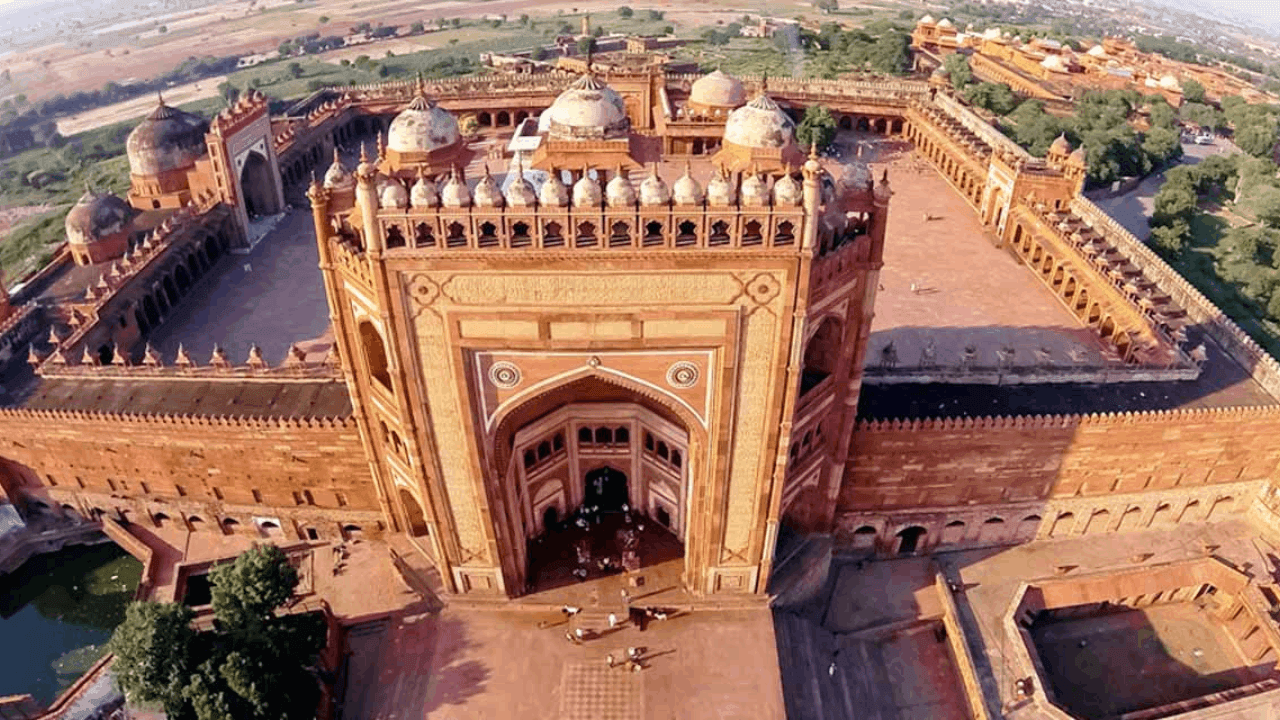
[342,607,785,720]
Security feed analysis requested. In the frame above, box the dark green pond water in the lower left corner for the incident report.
[0,543,142,705]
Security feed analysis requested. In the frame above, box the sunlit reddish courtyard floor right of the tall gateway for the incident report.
[860,133,1105,366]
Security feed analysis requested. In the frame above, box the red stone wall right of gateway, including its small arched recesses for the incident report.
[836,407,1280,544]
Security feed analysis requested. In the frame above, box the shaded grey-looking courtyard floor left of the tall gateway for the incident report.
[148,208,329,366]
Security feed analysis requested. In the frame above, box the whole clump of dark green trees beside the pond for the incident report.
[108,546,325,720]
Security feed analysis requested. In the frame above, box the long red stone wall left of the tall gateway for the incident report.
[0,411,379,521]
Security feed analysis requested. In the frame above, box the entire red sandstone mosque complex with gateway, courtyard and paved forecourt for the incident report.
[0,30,1280,720]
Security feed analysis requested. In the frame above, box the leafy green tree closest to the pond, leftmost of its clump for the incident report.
[106,602,196,717]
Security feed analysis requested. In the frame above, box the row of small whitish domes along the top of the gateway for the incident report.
[366,167,803,209]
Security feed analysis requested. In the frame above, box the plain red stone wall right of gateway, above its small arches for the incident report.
[837,407,1280,512]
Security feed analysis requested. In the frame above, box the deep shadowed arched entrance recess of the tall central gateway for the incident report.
[489,374,701,594]
